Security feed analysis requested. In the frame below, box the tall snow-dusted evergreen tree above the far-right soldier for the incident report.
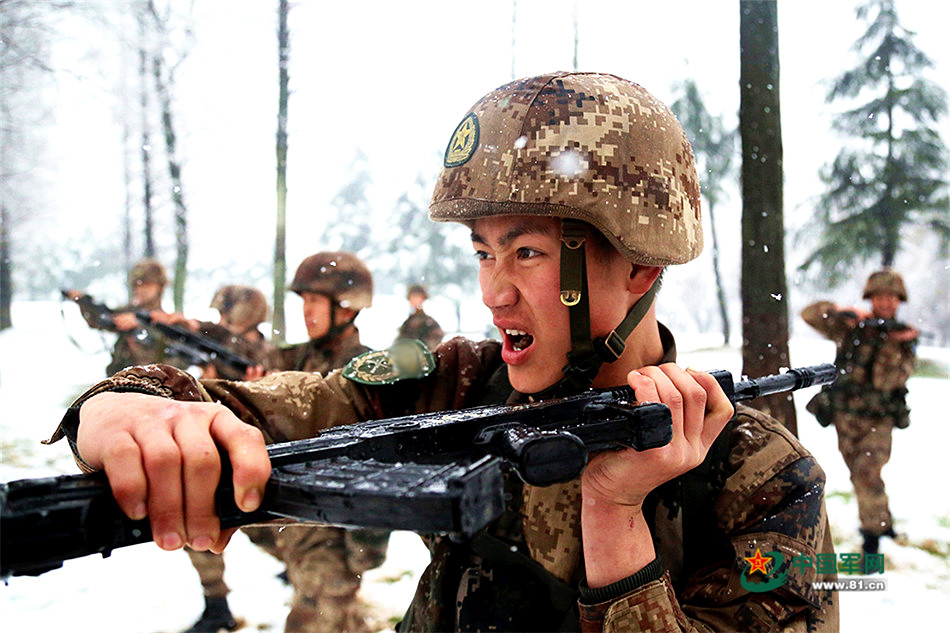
[802,0,950,283]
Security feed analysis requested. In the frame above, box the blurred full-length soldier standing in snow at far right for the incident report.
[802,269,919,554]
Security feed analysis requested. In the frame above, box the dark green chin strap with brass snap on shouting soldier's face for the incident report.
[531,219,657,399]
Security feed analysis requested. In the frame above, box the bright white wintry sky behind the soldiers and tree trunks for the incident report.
[0,0,950,344]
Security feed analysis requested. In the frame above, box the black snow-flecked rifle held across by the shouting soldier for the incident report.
[0,364,836,578]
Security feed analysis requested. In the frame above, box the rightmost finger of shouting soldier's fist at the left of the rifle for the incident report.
[211,407,271,512]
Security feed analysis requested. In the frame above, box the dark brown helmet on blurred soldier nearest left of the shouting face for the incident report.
[290,252,373,311]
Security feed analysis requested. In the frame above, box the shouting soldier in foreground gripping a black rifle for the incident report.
[53,73,838,632]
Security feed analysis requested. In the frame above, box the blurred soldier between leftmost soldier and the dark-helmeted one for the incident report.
[182,285,276,633]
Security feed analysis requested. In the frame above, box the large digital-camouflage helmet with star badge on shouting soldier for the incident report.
[429,72,703,266]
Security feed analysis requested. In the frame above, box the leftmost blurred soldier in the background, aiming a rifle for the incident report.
[68,258,188,376]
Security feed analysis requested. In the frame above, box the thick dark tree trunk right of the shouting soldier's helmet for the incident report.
[739,0,798,434]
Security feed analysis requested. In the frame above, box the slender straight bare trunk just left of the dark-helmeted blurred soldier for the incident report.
[271,0,290,343]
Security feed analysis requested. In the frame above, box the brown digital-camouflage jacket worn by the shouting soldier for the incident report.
[52,329,838,632]
